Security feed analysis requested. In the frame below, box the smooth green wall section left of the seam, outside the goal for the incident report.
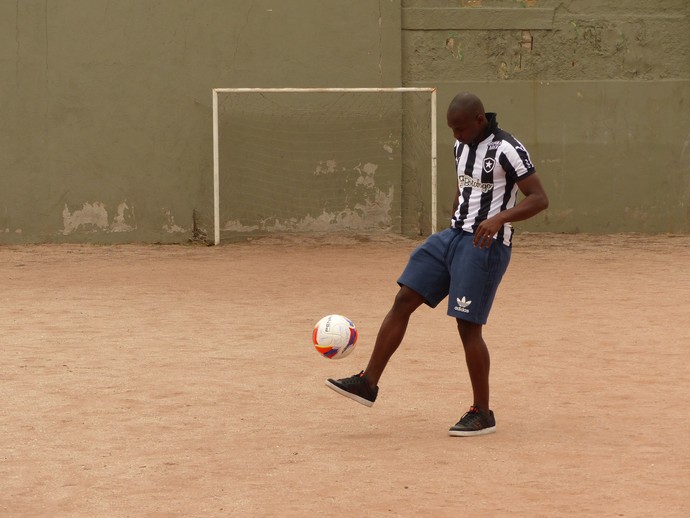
[0,0,401,243]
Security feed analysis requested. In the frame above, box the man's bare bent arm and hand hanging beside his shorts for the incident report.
[474,173,549,248]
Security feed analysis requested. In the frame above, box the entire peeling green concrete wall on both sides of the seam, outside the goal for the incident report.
[0,0,690,244]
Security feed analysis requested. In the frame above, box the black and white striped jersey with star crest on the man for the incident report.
[451,113,535,246]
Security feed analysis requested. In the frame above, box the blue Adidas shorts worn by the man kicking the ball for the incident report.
[398,228,511,324]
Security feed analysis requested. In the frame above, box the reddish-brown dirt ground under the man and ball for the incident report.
[0,234,690,517]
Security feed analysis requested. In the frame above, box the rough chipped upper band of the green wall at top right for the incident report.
[403,0,690,82]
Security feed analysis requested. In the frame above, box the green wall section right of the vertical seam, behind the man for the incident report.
[402,0,690,233]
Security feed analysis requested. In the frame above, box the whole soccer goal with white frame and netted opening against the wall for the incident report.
[213,87,437,244]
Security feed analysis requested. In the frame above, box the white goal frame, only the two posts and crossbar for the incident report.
[213,87,437,245]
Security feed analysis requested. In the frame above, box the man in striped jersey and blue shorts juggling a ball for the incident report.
[326,92,548,437]
